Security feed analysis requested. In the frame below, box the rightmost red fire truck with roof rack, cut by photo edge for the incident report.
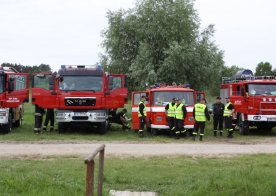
[220,70,276,134]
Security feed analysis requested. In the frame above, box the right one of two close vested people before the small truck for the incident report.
[174,98,187,139]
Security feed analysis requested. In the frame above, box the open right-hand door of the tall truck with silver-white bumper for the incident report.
[110,74,128,108]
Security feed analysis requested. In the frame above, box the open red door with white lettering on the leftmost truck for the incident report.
[5,73,29,108]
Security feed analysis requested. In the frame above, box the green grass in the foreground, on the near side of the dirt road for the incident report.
[0,155,276,196]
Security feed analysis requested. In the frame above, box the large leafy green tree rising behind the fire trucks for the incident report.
[101,0,224,93]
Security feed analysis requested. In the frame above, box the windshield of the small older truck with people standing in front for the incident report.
[153,91,194,106]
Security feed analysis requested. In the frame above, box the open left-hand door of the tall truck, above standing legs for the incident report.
[32,74,57,108]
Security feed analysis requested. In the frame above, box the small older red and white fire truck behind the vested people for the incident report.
[132,85,205,135]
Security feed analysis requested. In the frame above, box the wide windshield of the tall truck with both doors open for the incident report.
[59,76,103,92]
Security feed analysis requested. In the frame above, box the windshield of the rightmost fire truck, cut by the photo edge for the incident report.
[248,84,276,96]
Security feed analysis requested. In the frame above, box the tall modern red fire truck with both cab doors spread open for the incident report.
[32,65,128,134]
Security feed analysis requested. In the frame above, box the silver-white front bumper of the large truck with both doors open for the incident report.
[56,110,108,122]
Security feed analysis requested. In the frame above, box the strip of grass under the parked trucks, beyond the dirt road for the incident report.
[0,103,276,142]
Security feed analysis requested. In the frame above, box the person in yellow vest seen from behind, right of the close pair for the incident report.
[193,98,210,141]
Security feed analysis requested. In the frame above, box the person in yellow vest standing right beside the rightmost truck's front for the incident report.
[223,97,234,138]
